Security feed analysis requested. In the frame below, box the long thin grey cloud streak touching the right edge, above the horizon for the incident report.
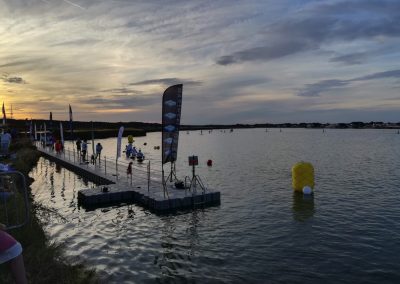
[297,70,400,97]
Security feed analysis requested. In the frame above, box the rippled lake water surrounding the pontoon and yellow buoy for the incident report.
[30,129,400,283]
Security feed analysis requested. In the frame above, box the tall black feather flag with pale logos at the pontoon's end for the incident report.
[162,84,183,164]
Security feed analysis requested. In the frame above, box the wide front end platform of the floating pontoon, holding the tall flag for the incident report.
[78,184,221,214]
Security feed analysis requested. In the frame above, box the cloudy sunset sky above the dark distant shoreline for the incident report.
[0,0,400,124]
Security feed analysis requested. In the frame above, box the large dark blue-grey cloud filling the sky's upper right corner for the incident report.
[216,1,400,65]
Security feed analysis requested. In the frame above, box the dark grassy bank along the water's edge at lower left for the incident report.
[0,140,99,283]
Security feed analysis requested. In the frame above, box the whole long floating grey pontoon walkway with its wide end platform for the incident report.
[37,146,221,213]
